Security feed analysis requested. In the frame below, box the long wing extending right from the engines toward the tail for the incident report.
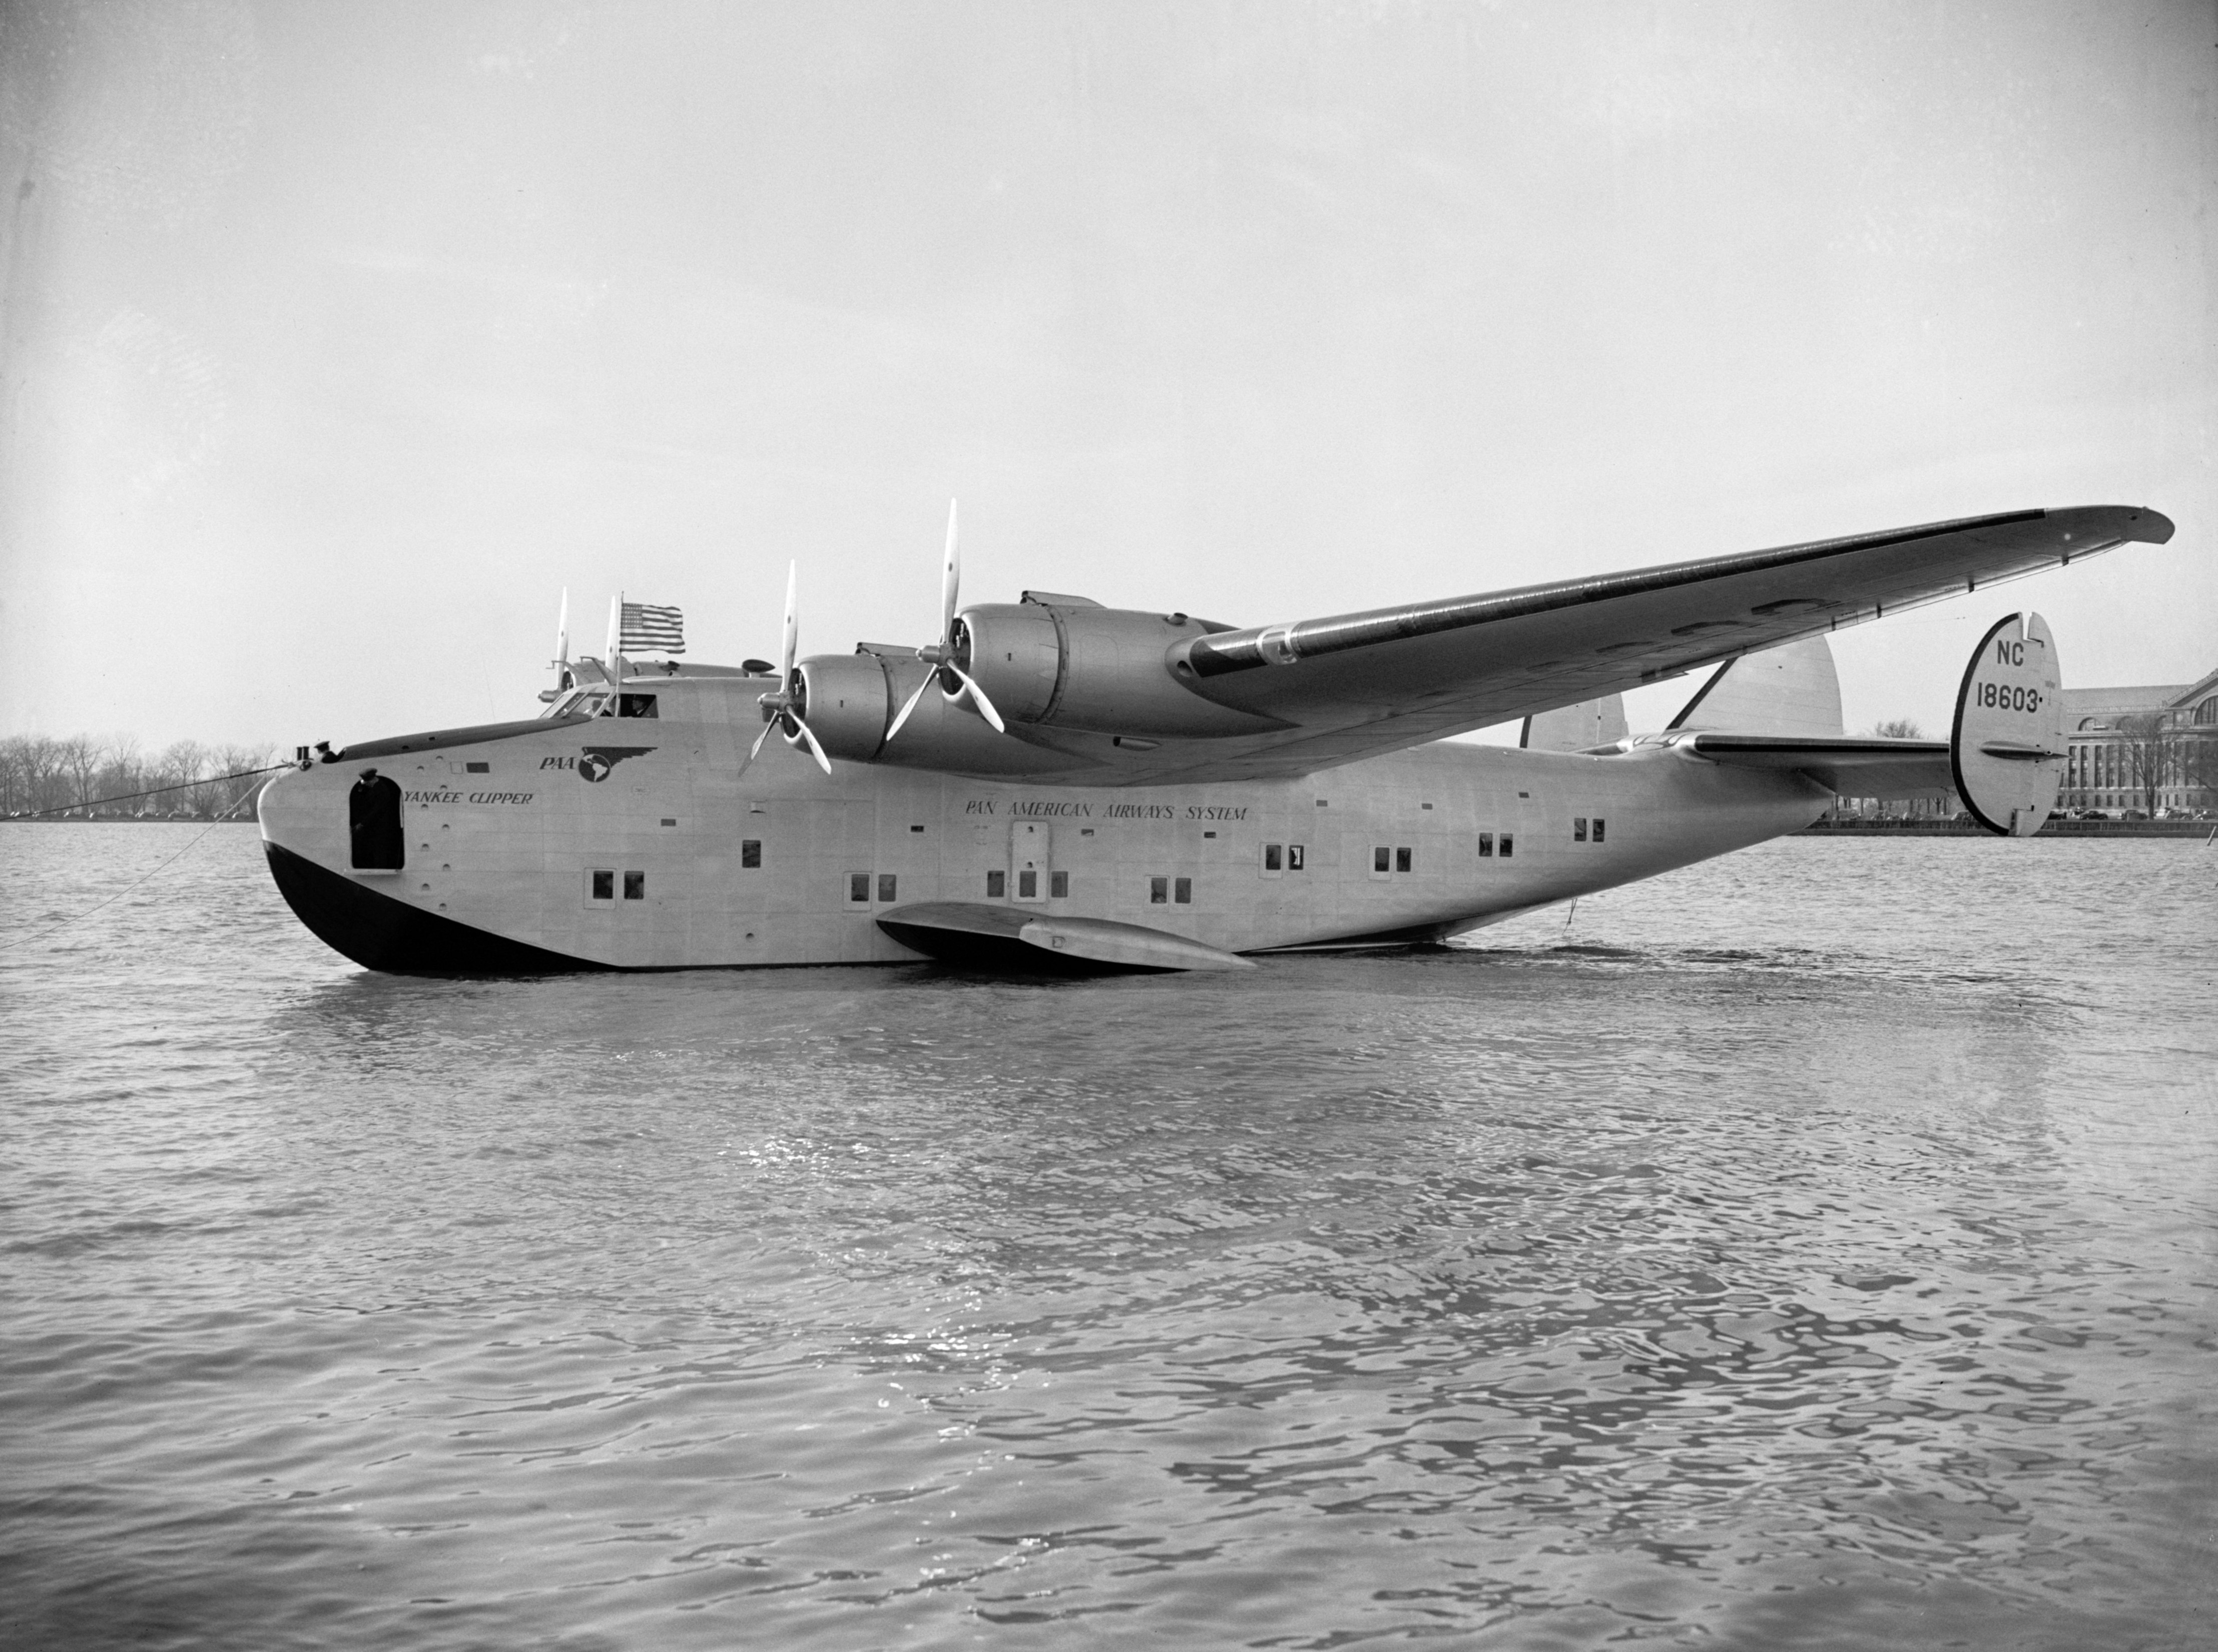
[1042,506,2171,785]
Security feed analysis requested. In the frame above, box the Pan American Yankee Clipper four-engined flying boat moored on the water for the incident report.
[260,506,2173,976]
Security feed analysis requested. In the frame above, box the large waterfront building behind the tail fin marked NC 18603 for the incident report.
[2056,670,2218,814]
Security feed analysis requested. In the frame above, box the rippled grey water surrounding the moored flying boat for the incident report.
[0,825,2218,1650]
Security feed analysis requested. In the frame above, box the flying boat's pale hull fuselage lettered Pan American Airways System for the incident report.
[262,705,1828,974]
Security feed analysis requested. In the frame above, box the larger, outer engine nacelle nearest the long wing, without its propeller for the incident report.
[962,596,1287,738]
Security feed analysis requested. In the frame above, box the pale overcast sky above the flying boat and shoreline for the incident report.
[0,0,2218,747]
